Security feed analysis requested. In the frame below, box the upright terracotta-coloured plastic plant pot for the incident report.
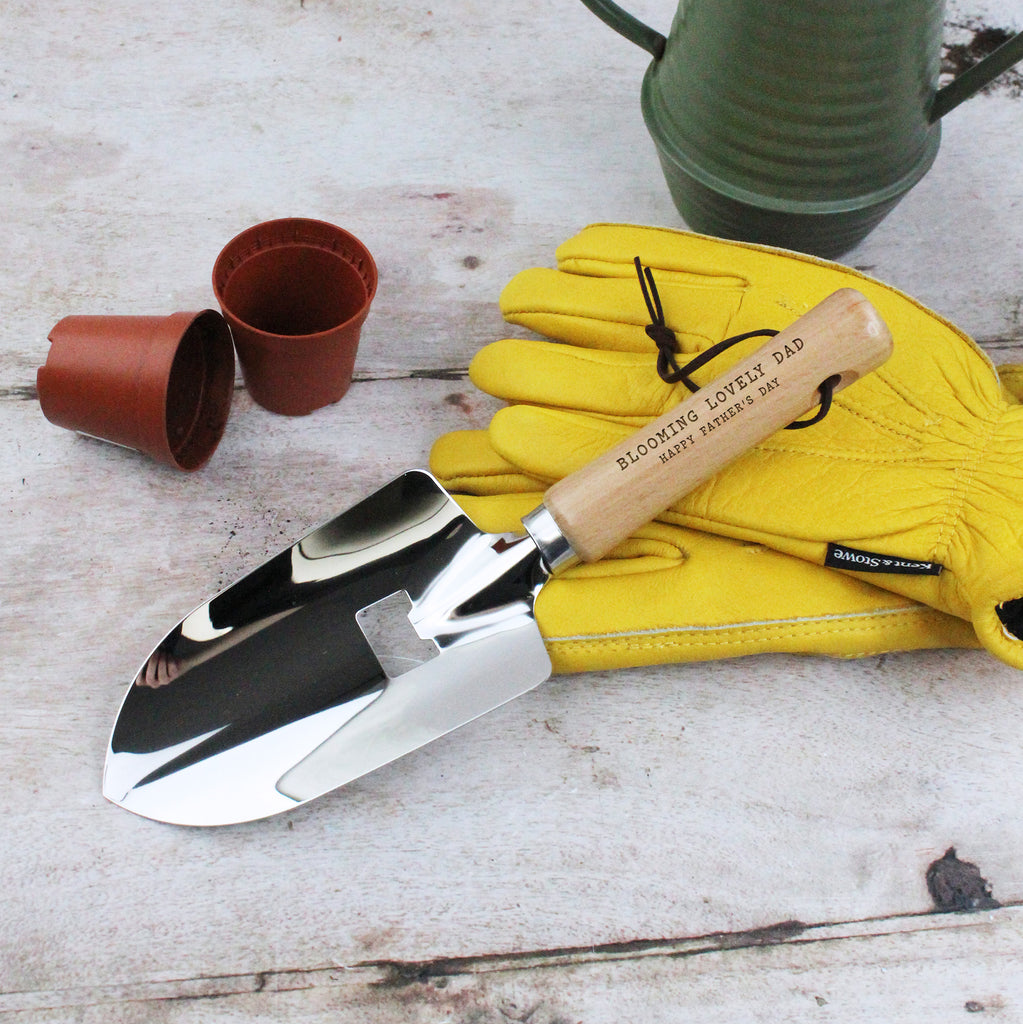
[213,217,377,416]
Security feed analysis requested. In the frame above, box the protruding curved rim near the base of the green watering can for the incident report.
[640,61,941,214]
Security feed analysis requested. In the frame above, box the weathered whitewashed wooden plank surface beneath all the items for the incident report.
[0,0,1023,1024]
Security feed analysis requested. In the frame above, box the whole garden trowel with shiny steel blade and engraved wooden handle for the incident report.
[103,289,892,825]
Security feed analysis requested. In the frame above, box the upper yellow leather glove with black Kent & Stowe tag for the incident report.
[470,224,1023,667]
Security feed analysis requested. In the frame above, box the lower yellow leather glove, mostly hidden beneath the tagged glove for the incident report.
[430,431,979,673]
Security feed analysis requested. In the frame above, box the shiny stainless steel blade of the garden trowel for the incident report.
[103,470,551,825]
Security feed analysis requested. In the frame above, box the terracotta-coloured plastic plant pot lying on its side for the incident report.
[36,309,235,471]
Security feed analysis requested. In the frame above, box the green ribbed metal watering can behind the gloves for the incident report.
[583,0,1023,258]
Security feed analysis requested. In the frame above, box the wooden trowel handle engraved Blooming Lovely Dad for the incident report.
[544,288,892,562]
